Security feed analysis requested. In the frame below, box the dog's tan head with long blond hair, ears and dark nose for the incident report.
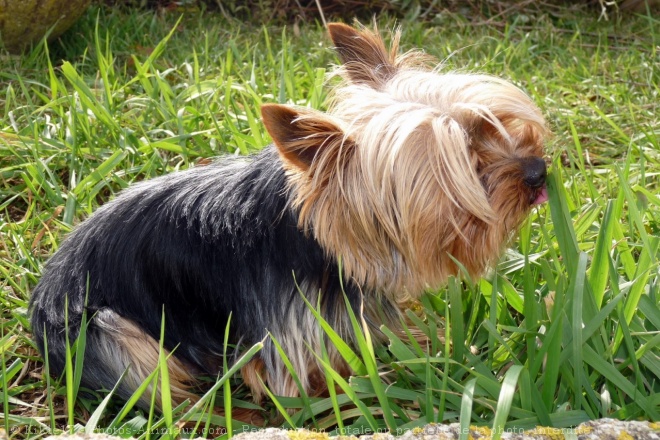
[262,24,547,295]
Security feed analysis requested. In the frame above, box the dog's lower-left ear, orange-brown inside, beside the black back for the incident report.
[261,104,352,171]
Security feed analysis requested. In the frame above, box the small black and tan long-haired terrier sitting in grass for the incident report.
[30,24,547,420]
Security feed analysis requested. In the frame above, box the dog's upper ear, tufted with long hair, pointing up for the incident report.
[328,23,400,89]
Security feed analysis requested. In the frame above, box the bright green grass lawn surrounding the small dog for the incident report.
[0,4,660,438]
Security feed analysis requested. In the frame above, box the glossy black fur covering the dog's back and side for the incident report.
[31,146,359,398]
